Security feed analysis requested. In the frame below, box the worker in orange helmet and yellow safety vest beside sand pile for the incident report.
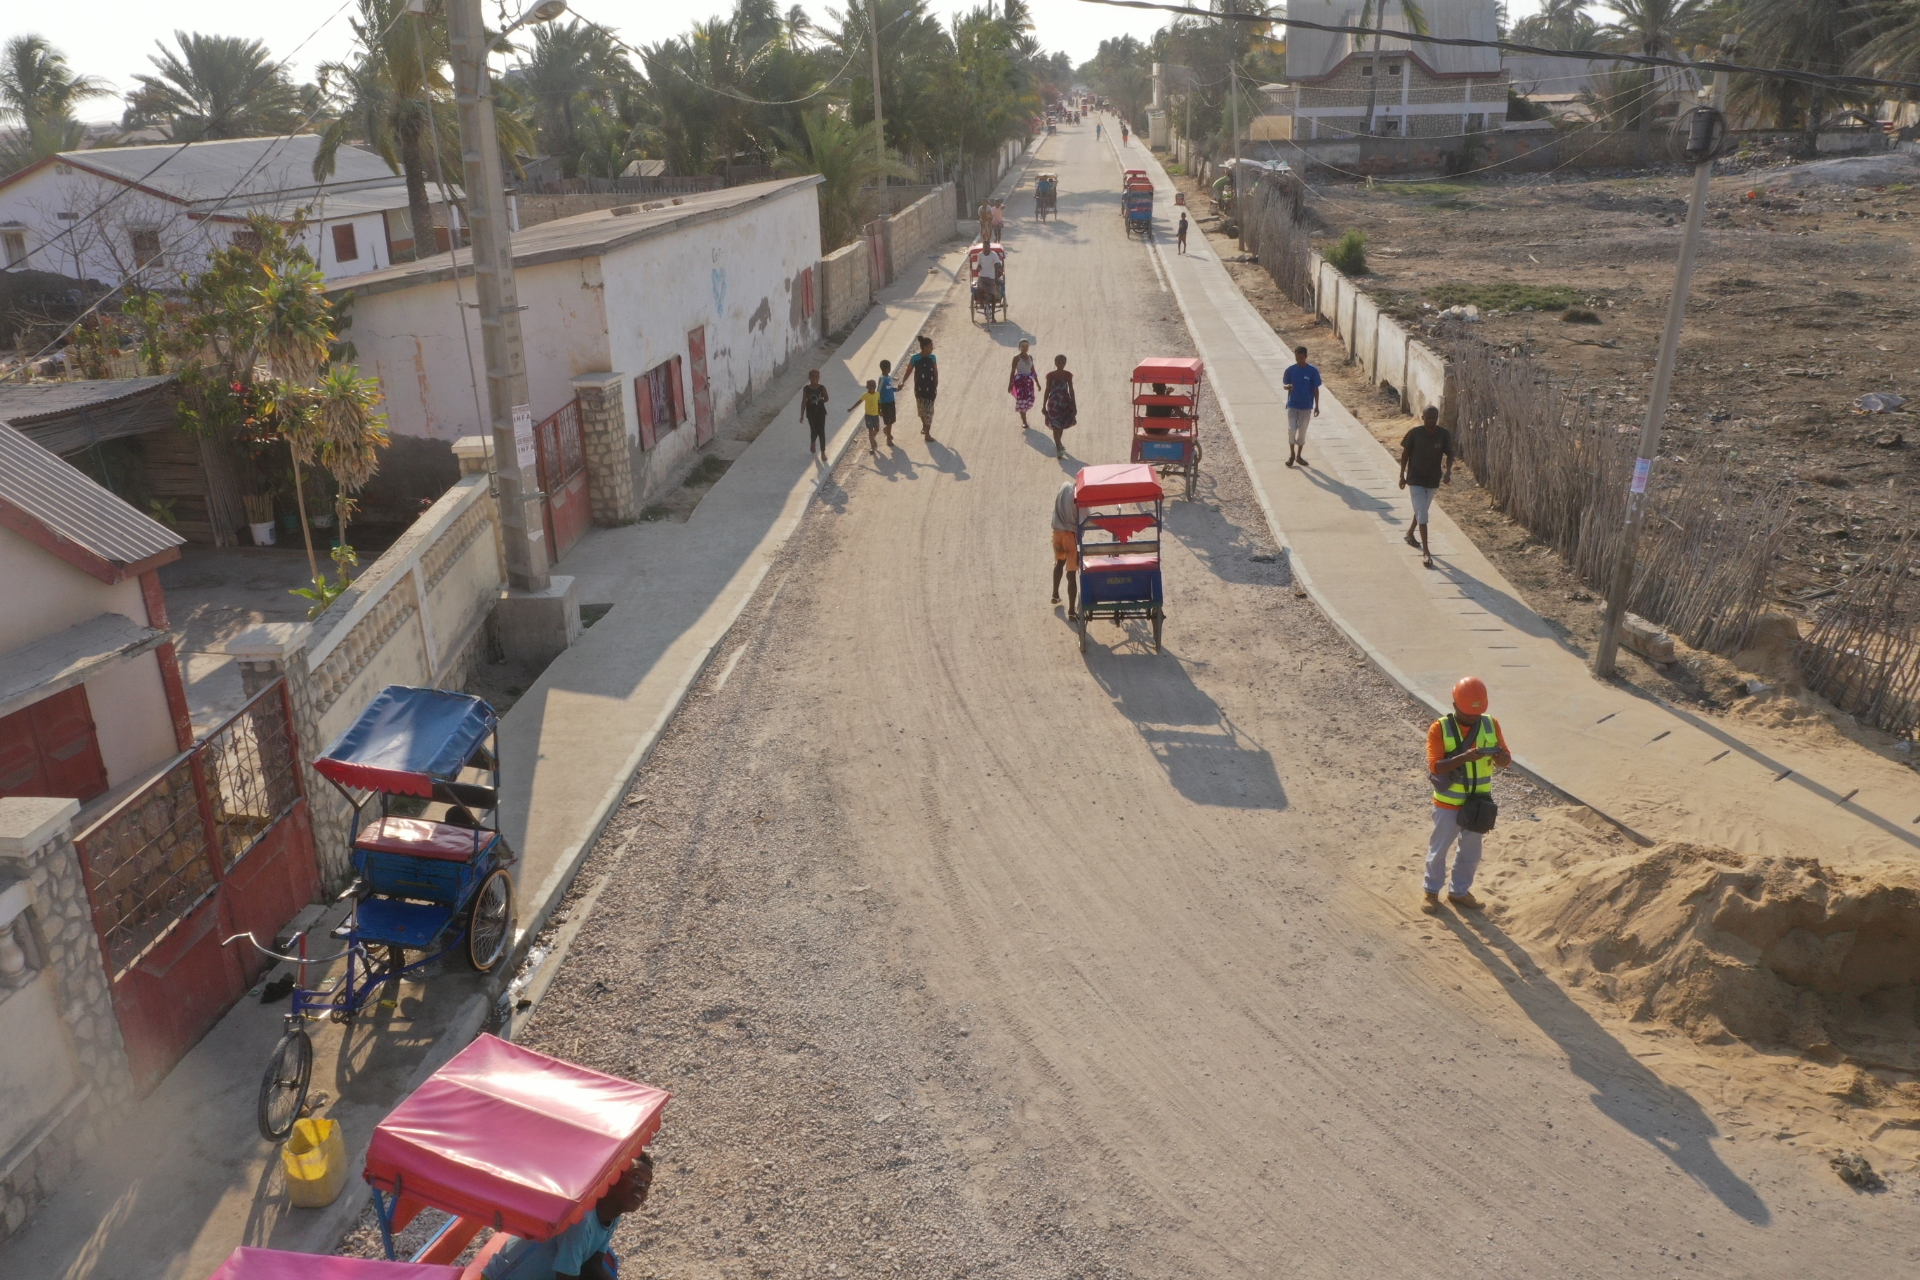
[1421,676,1513,913]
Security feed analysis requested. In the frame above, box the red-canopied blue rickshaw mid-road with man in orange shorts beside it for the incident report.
[1073,462,1167,652]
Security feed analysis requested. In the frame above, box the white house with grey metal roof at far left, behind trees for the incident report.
[0,134,457,288]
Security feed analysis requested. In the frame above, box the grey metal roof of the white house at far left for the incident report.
[60,134,394,203]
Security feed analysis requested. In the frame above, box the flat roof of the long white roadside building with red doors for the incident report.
[341,173,822,296]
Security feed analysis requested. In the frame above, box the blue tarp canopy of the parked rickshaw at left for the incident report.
[313,685,499,796]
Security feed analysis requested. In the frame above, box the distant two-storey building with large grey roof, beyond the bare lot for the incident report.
[1250,0,1507,142]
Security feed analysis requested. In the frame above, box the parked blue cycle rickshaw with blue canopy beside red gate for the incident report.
[242,685,516,1142]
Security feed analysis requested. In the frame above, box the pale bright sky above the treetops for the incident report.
[0,0,1559,119]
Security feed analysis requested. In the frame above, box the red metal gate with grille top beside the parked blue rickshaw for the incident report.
[75,681,321,1092]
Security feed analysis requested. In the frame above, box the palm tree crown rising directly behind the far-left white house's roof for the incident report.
[125,31,305,142]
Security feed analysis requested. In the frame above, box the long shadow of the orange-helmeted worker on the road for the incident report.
[1440,912,1772,1226]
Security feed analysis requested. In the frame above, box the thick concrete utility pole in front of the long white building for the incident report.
[447,0,566,591]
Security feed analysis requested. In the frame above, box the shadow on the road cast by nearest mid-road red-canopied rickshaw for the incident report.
[1085,640,1286,810]
